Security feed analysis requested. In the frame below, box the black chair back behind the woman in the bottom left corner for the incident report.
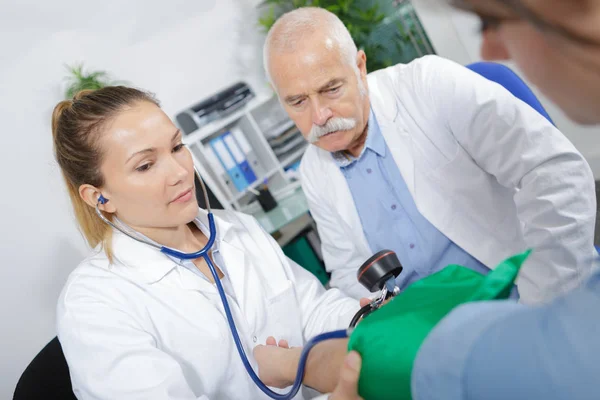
[13,337,77,400]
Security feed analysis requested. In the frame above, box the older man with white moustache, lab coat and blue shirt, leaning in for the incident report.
[264,8,596,303]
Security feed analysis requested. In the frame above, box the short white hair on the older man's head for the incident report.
[263,7,361,84]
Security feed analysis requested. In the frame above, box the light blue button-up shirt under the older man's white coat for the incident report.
[333,110,516,295]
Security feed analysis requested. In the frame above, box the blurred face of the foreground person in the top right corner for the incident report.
[453,0,600,124]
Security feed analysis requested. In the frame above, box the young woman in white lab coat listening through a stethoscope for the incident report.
[52,87,359,400]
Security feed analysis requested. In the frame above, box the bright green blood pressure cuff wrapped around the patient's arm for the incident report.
[348,251,530,400]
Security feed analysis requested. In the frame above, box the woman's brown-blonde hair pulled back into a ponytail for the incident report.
[52,86,160,262]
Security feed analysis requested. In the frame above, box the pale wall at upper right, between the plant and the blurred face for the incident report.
[412,0,600,180]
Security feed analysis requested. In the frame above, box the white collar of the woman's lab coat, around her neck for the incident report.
[112,209,232,284]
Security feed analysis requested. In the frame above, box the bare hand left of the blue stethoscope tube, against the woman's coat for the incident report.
[254,337,302,389]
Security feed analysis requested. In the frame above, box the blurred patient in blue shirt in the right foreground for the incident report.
[254,0,600,400]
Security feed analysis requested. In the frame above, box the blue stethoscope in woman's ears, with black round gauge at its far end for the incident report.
[96,168,402,400]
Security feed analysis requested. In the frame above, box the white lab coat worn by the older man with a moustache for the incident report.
[300,56,596,303]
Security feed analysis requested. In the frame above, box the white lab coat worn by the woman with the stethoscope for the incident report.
[57,210,359,400]
